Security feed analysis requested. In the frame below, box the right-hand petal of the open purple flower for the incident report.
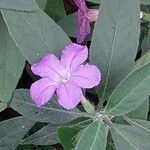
[71,64,101,88]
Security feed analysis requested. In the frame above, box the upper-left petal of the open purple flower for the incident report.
[31,54,64,81]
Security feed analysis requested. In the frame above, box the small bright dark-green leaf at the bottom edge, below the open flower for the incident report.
[58,127,79,150]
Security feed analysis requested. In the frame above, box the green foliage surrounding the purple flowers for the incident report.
[0,0,150,150]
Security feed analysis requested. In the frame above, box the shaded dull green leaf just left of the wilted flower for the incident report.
[58,13,77,37]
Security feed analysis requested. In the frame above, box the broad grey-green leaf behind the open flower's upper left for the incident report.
[2,10,70,64]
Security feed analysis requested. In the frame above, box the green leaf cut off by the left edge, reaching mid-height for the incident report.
[0,14,25,103]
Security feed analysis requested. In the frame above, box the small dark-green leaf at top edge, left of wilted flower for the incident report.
[46,0,66,22]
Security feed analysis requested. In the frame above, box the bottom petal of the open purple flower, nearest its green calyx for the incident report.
[57,82,82,110]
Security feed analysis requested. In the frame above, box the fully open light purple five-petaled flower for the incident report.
[30,44,101,109]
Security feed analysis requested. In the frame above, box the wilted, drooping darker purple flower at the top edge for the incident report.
[74,0,98,43]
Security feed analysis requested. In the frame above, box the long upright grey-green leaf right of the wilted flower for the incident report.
[90,0,140,101]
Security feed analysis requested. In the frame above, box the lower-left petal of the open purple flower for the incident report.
[30,78,57,107]
